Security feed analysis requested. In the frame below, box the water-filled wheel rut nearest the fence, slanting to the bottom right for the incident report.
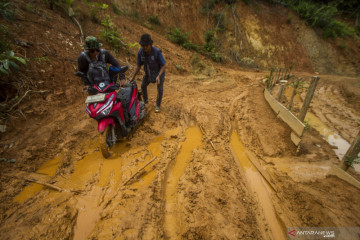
[230,132,286,240]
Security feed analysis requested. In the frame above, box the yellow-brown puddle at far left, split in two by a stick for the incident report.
[14,157,61,203]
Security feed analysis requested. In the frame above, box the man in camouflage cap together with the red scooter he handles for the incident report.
[76,36,146,158]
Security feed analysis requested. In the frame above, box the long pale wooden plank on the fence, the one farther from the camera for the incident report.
[264,89,305,137]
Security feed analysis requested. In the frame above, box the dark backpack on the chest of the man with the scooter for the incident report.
[81,49,110,84]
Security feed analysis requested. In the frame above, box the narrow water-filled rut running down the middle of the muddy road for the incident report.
[165,126,203,239]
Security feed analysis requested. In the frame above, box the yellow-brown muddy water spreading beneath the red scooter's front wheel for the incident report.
[70,128,180,240]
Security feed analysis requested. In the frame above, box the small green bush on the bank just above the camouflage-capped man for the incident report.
[100,15,127,52]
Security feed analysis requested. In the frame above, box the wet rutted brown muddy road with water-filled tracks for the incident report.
[0,67,360,240]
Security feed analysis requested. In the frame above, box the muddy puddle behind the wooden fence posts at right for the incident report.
[305,112,360,172]
